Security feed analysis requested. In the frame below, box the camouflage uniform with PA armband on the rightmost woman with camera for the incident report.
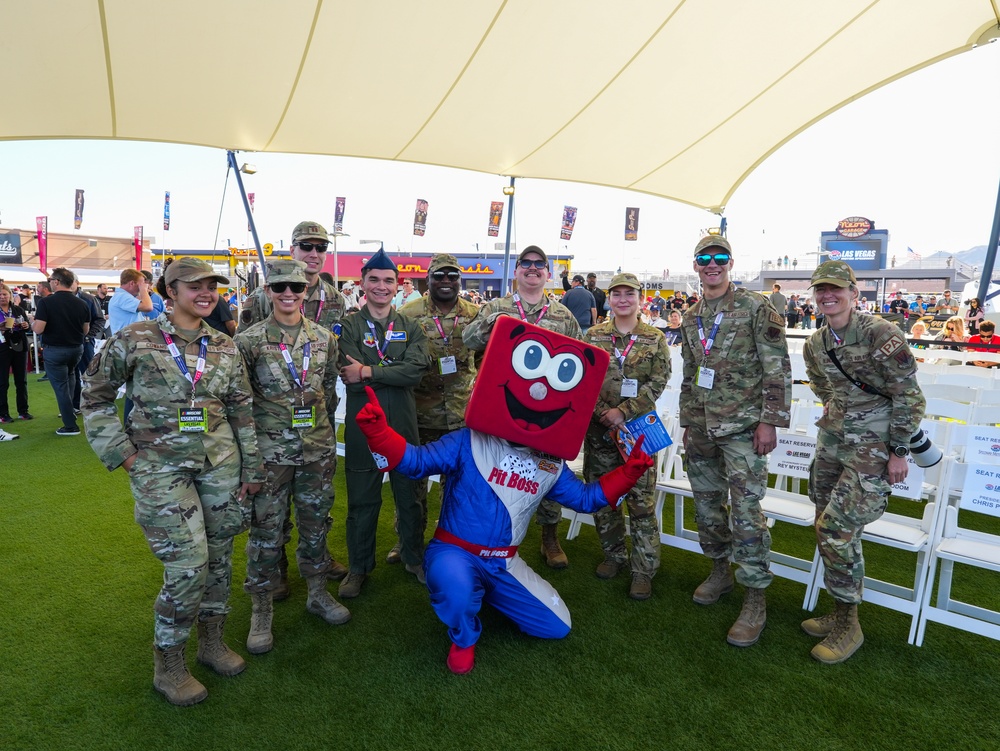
[803,312,926,604]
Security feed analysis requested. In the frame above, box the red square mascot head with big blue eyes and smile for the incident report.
[465,316,611,459]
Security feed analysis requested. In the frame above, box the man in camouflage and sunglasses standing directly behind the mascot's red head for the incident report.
[462,245,582,568]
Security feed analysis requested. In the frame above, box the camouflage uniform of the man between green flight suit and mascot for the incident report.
[399,295,479,531]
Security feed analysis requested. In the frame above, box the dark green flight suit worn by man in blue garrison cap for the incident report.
[340,305,428,574]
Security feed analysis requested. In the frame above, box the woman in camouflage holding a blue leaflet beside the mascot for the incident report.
[583,274,670,600]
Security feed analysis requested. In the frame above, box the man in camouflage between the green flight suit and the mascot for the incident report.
[386,253,479,563]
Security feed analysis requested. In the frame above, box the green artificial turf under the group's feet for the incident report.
[0,375,1000,751]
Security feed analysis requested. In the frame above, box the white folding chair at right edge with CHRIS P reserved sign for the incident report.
[916,462,1000,647]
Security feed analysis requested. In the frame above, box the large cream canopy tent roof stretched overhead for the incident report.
[0,0,1000,211]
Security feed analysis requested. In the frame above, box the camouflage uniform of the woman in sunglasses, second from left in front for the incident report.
[236,315,338,593]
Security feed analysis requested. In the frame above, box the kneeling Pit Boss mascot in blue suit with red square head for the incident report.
[357,316,653,673]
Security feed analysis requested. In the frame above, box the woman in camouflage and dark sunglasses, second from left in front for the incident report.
[235,259,351,654]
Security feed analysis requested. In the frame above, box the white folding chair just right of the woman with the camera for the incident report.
[807,458,953,644]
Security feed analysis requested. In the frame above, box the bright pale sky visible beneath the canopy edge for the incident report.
[0,39,1000,274]
